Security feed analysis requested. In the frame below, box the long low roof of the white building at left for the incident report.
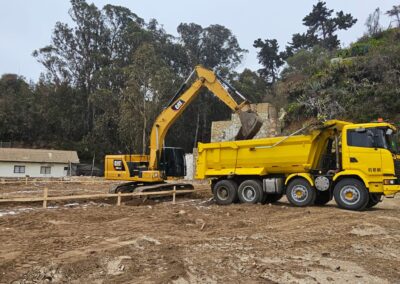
[0,148,79,164]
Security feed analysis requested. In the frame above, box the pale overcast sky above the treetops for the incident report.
[0,0,400,81]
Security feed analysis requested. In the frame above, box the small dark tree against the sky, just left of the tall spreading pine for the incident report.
[253,38,284,83]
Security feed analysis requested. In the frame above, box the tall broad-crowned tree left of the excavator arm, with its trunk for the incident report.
[33,0,144,132]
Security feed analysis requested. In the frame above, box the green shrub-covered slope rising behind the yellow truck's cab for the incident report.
[282,28,400,125]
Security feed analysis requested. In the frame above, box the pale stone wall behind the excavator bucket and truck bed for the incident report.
[211,103,282,142]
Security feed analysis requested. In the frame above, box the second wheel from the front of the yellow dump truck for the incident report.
[286,178,316,207]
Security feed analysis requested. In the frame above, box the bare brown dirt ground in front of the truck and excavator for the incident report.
[0,183,400,283]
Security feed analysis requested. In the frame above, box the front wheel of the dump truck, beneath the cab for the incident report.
[333,178,369,211]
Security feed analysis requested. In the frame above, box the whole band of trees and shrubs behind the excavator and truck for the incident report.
[0,0,400,162]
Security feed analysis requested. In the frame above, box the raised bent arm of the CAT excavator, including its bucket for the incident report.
[149,66,262,170]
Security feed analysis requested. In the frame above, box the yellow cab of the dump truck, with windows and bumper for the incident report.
[334,122,400,195]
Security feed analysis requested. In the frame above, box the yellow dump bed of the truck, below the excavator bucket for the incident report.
[196,130,326,179]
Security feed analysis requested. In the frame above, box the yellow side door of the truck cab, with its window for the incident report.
[343,128,382,176]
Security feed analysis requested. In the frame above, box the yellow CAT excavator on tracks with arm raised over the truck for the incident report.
[104,66,262,193]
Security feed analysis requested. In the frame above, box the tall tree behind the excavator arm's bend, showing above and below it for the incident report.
[177,23,247,149]
